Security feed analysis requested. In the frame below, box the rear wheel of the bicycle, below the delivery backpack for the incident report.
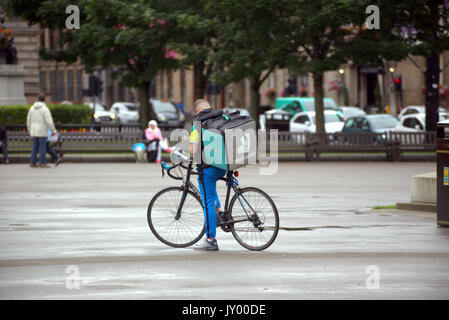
[229,187,279,251]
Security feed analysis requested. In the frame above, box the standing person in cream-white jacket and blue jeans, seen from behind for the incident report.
[27,94,56,168]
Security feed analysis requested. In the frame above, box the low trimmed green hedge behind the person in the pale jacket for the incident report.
[0,104,91,125]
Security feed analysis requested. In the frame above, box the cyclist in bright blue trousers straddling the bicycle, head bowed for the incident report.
[190,99,226,251]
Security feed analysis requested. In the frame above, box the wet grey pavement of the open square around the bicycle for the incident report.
[0,162,449,299]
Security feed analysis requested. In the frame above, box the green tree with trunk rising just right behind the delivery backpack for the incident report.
[207,0,288,119]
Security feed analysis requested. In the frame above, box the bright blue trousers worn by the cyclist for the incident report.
[198,167,226,238]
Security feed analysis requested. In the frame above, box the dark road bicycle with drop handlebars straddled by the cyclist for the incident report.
[147,150,279,251]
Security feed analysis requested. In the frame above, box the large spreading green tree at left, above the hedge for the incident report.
[2,0,180,127]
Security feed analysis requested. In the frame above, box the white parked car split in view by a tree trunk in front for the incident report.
[290,110,344,133]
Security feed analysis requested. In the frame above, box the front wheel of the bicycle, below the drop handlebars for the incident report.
[147,187,205,248]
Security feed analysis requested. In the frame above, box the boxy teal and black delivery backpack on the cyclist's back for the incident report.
[195,110,257,171]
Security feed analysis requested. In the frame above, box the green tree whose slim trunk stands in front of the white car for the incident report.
[283,0,376,133]
